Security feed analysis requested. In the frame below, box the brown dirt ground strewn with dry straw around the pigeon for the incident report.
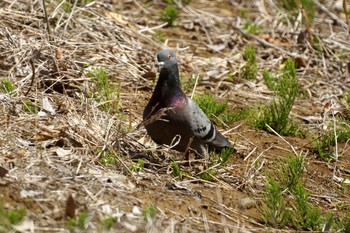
[0,0,350,232]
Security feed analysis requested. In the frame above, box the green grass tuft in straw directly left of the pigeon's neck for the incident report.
[88,67,120,112]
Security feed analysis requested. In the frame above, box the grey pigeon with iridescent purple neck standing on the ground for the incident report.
[143,50,231,157]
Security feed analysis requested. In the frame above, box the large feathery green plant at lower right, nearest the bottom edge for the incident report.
[259,156,322,230]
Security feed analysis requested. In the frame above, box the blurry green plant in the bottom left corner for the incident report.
[0,203,27,232]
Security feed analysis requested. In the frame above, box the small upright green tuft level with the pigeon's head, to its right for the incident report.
[241,46,258,80]
